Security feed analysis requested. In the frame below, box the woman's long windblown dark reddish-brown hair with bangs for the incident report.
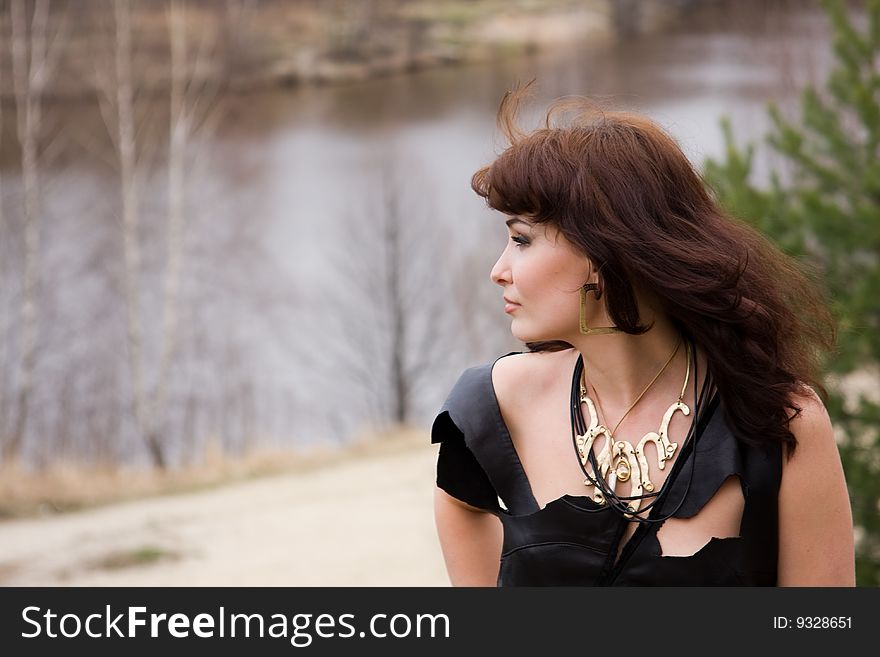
[471,83,835,455]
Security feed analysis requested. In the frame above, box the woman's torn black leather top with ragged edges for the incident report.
[431,352,782,586]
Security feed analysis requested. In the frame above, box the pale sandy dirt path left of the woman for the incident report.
[0,445,449,586]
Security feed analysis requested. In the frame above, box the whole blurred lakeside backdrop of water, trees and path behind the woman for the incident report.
[0,0,880,585]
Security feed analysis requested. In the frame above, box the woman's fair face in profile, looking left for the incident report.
[490,217,605,342]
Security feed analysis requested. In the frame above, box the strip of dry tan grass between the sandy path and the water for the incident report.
[0,429,429,520]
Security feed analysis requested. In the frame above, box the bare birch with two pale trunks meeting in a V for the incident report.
[98,0,262,468]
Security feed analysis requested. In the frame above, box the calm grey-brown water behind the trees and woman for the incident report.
[3,1,830,460]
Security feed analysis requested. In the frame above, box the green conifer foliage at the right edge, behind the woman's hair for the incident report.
[704,0,880,586]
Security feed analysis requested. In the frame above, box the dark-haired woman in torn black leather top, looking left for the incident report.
[432,87,854,586]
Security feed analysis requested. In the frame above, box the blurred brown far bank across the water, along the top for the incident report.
[0,0,700,103]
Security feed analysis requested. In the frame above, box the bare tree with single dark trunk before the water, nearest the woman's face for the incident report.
[311,156,450,430]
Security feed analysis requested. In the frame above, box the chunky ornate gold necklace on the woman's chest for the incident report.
[576,339,691,518]
